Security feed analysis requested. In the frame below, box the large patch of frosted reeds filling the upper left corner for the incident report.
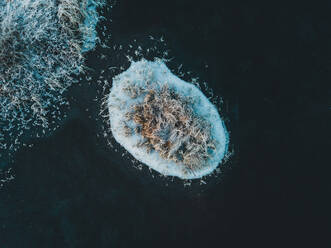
[0,0,103,156]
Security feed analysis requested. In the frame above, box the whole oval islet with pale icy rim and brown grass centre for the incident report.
[107,60,229,179]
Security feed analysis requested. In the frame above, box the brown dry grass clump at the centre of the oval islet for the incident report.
[125,83,215,172]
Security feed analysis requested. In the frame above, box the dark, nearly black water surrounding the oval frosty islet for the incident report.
[0,0,331,248]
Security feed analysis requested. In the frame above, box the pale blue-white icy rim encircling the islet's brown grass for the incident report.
[107,60,229,179]
